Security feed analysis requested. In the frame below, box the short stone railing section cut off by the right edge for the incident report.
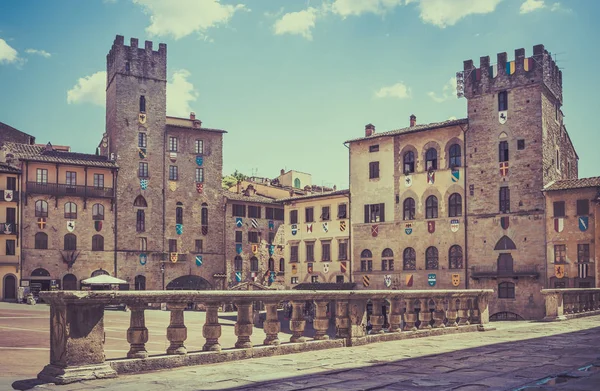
[542,288,600,322]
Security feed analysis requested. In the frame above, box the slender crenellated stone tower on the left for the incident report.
[102,35,167,278]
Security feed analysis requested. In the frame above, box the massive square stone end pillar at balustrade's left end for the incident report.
[38,304,117,384]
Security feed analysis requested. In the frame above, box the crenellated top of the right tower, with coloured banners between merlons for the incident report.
[463,45,562,104]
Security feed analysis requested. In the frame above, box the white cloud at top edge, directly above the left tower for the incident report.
[133,0,249,39]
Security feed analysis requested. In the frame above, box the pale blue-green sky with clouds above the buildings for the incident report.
[0,0,600,189]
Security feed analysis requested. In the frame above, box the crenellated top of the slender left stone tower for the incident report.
[106,35,167,86]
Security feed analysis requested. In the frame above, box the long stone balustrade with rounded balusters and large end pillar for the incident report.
[38,290,493,384]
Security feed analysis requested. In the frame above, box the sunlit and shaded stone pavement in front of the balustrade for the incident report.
[12,316,600,391]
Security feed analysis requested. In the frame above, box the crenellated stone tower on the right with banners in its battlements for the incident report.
[463,45,577,318]
